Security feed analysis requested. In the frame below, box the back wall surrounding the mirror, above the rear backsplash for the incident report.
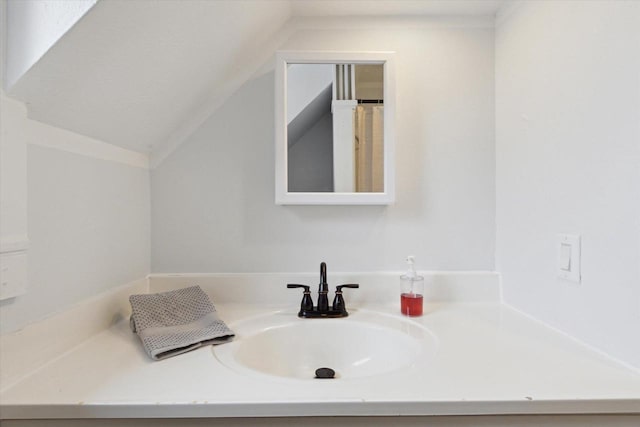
[151,19,495,272]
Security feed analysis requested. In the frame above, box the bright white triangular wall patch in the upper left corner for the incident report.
[2,0,98,88]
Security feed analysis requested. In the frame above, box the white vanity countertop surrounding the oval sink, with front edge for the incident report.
[0,303,640,419]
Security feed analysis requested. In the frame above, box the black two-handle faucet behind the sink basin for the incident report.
[287,262,360,318]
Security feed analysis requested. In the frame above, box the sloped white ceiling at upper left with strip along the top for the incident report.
[9,0,503,167]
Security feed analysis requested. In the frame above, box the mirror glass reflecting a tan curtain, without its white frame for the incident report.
[287,64,384,193]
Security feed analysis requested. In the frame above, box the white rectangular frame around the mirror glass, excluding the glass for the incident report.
[275,51,396,205]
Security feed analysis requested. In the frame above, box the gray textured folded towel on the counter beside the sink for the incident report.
[129,286,234,360]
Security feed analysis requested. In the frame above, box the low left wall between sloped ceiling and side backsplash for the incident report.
[0,95,150,333]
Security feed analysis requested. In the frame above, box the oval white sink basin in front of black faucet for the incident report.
[213,311,436,381]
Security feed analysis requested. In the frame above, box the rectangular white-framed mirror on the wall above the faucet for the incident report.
[275,51,395,205]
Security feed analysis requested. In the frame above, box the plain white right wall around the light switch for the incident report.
[496,1,640,367]
